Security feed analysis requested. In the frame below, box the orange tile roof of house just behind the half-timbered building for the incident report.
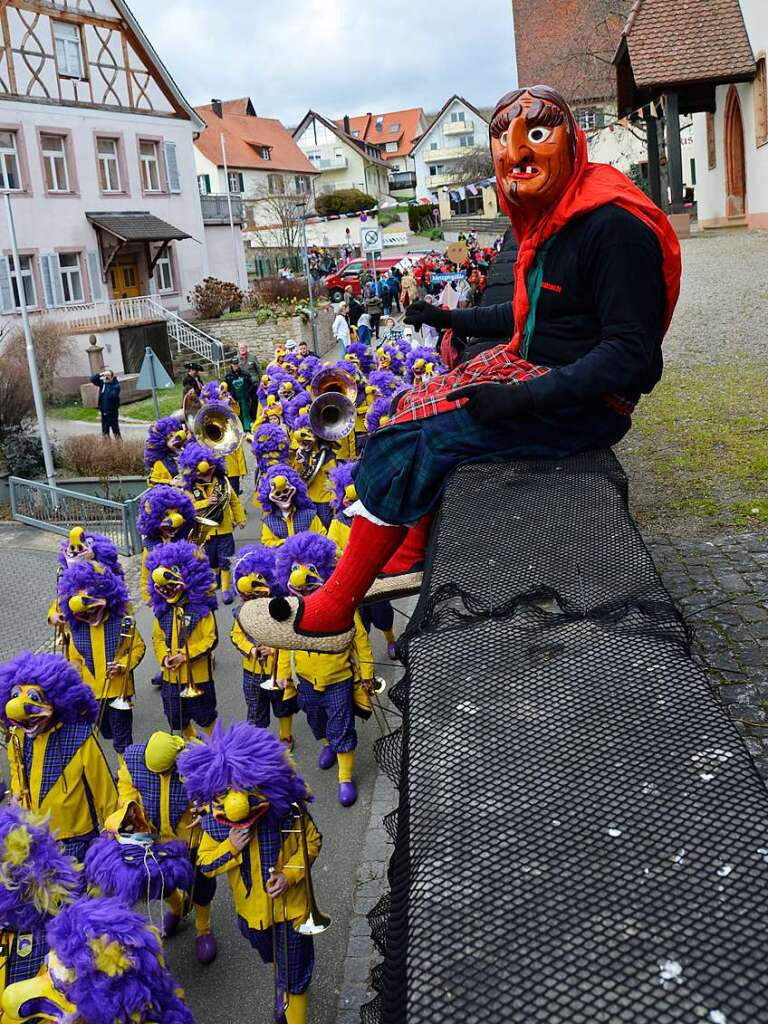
[195,96,319,174]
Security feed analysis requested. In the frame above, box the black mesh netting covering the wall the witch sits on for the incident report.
[361,454,768,1024]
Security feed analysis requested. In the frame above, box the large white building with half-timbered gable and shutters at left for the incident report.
[0,0,236,385]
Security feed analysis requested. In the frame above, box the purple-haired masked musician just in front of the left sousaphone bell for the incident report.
[179,441,246,604]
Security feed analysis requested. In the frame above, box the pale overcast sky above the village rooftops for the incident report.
[128,0,516,125]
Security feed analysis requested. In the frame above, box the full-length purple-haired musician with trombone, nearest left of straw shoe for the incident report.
[146,541,218,738]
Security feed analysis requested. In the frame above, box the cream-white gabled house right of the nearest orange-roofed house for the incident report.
[293,111,389,202]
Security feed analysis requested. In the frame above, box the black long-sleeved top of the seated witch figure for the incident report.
[451,204,665,409]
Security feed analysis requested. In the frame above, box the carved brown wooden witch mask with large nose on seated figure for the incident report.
[490,85,575,213]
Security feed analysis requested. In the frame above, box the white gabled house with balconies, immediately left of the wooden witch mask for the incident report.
[411,95,488,207]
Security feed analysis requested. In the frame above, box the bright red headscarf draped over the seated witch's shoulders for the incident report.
[497,120,682,353]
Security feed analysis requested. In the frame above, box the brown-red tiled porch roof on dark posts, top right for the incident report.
[624,0,755,87]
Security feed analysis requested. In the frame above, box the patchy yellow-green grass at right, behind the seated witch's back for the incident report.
[616,357,768,537]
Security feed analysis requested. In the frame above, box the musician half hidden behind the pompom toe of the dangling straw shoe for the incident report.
[229,544,298,750]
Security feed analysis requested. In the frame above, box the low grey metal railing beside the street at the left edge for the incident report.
[8,476,141,555]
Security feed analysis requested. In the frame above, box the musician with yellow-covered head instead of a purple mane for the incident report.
[118,731,218,964]
